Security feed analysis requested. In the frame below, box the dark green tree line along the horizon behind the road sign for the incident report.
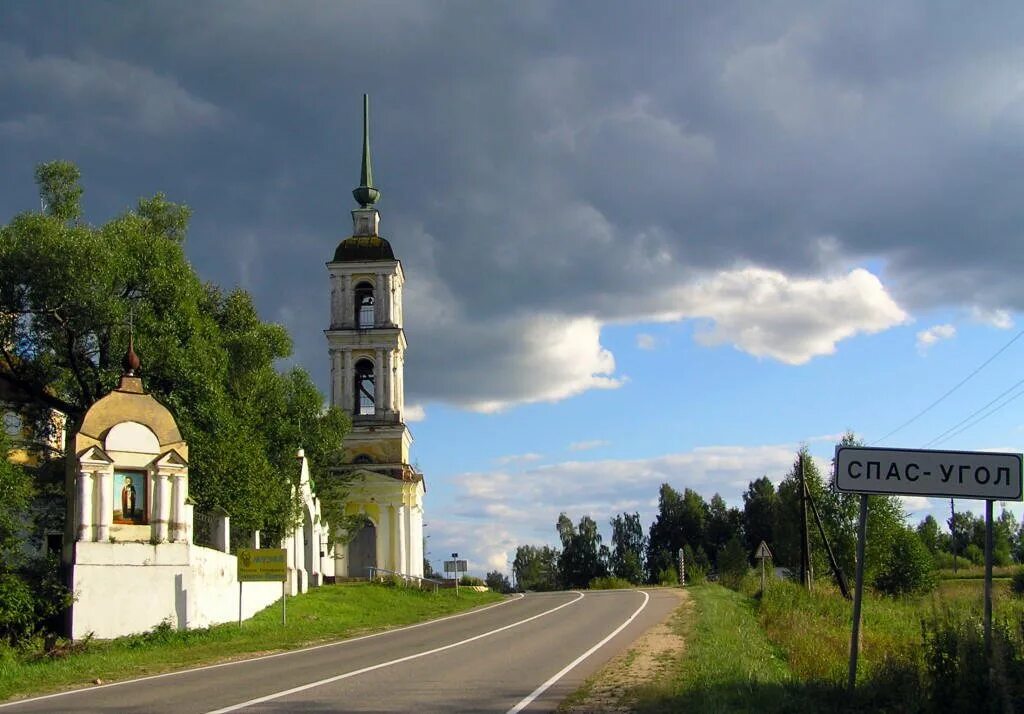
[503,433,1024,594]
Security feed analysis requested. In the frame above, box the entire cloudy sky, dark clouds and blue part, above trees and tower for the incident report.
[0,0,1024,575]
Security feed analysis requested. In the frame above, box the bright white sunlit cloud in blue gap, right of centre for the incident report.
[676,267,908,365]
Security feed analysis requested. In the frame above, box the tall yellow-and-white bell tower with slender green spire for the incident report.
[325,94,424,577]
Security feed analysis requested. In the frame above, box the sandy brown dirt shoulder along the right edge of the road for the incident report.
[558,588,693,714]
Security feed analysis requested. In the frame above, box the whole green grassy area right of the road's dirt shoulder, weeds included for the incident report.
[589,578,1024,713]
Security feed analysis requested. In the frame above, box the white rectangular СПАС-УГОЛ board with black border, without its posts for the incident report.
[836,447,1022,501]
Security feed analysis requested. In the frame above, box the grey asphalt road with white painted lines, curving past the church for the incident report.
[0,589,679,714]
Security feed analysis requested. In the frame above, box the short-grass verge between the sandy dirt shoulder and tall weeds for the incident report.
[630,584,813,714]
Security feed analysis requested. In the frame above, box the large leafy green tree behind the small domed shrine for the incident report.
[0,162,347,533]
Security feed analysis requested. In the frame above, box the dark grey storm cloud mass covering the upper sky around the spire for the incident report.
[0,2,1024,405]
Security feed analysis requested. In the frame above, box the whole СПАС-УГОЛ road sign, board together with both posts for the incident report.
[836,447,1024,690]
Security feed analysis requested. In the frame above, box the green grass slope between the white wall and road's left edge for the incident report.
[0,583,503,701]
